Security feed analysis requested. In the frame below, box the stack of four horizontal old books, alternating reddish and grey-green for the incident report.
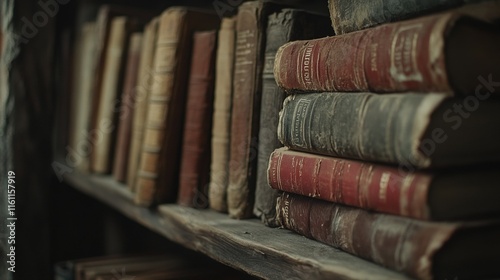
[267,1,500,279]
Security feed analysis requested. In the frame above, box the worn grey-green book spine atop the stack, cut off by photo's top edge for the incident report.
[328,0,464,34]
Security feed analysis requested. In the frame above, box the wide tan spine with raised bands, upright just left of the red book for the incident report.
[135,9,186,205]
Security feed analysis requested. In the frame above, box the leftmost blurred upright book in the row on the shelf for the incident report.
[68,22,96,172]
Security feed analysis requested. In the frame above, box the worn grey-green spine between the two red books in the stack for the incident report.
[278,92,446,168]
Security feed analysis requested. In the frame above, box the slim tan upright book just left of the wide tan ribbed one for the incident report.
[126,18,159,191]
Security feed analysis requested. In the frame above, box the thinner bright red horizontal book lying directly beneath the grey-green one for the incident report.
[267,148,500,220]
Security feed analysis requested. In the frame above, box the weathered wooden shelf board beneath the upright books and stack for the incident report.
[65,173,408,280]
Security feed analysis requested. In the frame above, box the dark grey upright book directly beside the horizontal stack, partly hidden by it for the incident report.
[253,9,333,226]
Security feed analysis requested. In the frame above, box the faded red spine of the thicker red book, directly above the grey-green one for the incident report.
[274,13,458,94]
